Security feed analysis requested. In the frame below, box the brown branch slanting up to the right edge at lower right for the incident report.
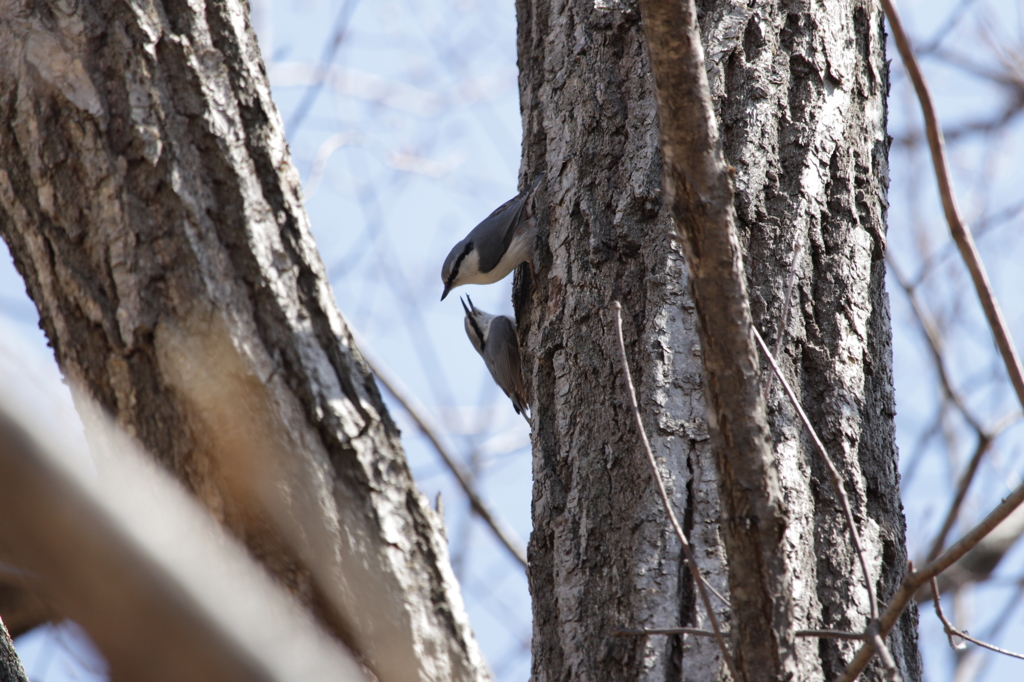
[837,483,1024,682]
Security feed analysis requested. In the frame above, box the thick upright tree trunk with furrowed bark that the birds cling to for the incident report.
[516,0,921,680]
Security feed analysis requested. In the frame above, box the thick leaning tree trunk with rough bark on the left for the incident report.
[0,0,486,681]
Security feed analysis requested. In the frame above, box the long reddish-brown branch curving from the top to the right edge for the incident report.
[882,0,1024,406]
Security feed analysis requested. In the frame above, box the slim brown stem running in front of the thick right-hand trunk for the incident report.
[640,0,796,680]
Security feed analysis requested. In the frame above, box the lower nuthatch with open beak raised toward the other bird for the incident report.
[459,296,530,424]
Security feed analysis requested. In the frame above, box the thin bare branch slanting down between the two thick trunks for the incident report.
[348,324,527,568]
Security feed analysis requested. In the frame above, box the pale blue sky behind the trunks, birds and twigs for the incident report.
[6,0,1024,682]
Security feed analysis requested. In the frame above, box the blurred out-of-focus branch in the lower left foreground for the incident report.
[0,387,367,682]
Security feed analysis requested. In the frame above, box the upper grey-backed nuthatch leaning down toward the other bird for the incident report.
[441,173,544,301]
